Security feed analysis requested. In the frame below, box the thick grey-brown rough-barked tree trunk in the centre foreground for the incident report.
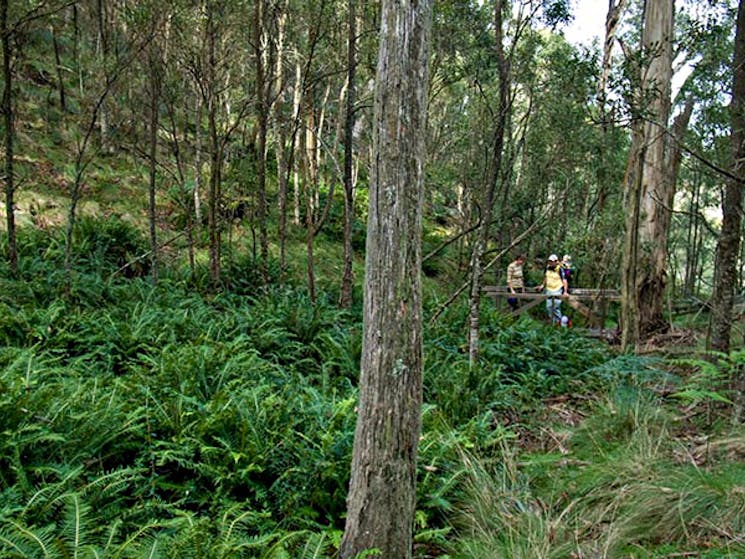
[340,0,432,559]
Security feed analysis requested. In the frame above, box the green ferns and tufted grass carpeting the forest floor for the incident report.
[0,220,745,559]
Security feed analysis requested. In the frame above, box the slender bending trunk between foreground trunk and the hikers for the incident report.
[468,0,510,365]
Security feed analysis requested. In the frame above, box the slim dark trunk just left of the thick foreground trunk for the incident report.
[340,0,357,309]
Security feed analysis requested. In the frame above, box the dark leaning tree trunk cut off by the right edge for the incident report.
[709,0,745,354]
